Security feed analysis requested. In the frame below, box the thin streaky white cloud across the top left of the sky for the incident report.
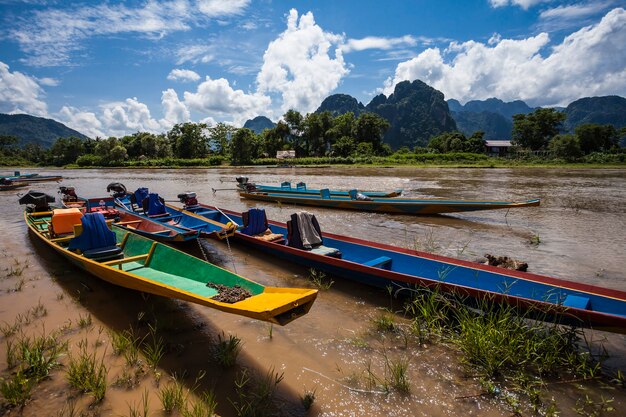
[9,0,249,66]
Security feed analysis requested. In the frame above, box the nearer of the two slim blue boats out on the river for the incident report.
[239,191,540,215]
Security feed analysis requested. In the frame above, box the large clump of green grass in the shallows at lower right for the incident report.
[402,288,602,414]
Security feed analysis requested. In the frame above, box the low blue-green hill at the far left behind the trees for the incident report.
[0,113,87,148]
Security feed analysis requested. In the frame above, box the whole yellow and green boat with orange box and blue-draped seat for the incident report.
[20,192,317,325]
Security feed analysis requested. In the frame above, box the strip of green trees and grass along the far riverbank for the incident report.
[0,105,626,167]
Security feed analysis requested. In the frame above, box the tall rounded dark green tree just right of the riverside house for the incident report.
[512,108,567,150]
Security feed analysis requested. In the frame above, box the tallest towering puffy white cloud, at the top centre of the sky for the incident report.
[257,9,348,113]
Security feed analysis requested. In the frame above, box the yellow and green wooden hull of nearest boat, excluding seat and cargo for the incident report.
[24,211,317,325]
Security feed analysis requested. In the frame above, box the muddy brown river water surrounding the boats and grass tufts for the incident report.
[0,167,626,417]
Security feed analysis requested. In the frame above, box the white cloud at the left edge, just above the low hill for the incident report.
[0,61,48,116]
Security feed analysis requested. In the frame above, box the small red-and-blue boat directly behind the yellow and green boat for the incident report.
[59,186,200,242]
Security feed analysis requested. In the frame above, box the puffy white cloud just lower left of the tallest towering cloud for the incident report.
[184,77,272,124]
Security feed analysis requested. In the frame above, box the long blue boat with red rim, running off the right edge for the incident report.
[167,197,626,333]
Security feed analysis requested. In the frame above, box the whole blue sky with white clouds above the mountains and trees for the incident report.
[0,0,626,137]
